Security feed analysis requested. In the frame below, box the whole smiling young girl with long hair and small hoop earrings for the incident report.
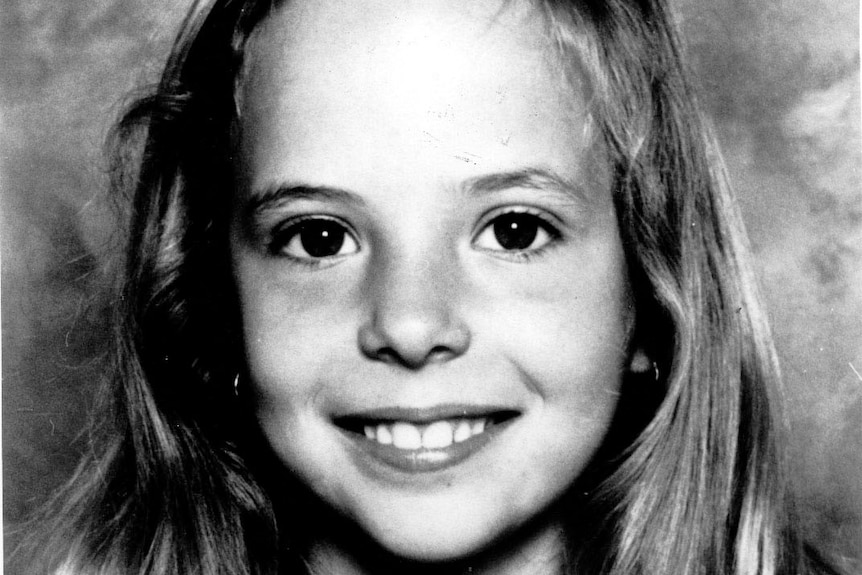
[32,0,844,575]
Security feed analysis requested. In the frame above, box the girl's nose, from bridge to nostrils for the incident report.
[359,254,471,369]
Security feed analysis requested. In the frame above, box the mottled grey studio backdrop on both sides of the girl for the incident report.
[0,0,862,570]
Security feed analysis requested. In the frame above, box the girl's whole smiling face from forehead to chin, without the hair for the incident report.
[231,0,634,560]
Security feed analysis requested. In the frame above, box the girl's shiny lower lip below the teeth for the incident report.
[347,419,513,473]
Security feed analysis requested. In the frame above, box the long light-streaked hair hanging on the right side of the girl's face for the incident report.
[542,0,840,575]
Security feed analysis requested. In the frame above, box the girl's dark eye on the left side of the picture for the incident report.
[270,217,359,260]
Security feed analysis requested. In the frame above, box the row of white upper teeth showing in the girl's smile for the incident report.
[364,418,486,449]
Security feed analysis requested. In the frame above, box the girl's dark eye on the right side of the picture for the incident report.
[474,211,560,252]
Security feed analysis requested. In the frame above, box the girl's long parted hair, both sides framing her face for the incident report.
[30,0,831,575]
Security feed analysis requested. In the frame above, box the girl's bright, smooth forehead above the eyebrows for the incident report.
[238,0,588,191]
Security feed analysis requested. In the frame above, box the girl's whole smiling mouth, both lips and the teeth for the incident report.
[334,407,520,473]
